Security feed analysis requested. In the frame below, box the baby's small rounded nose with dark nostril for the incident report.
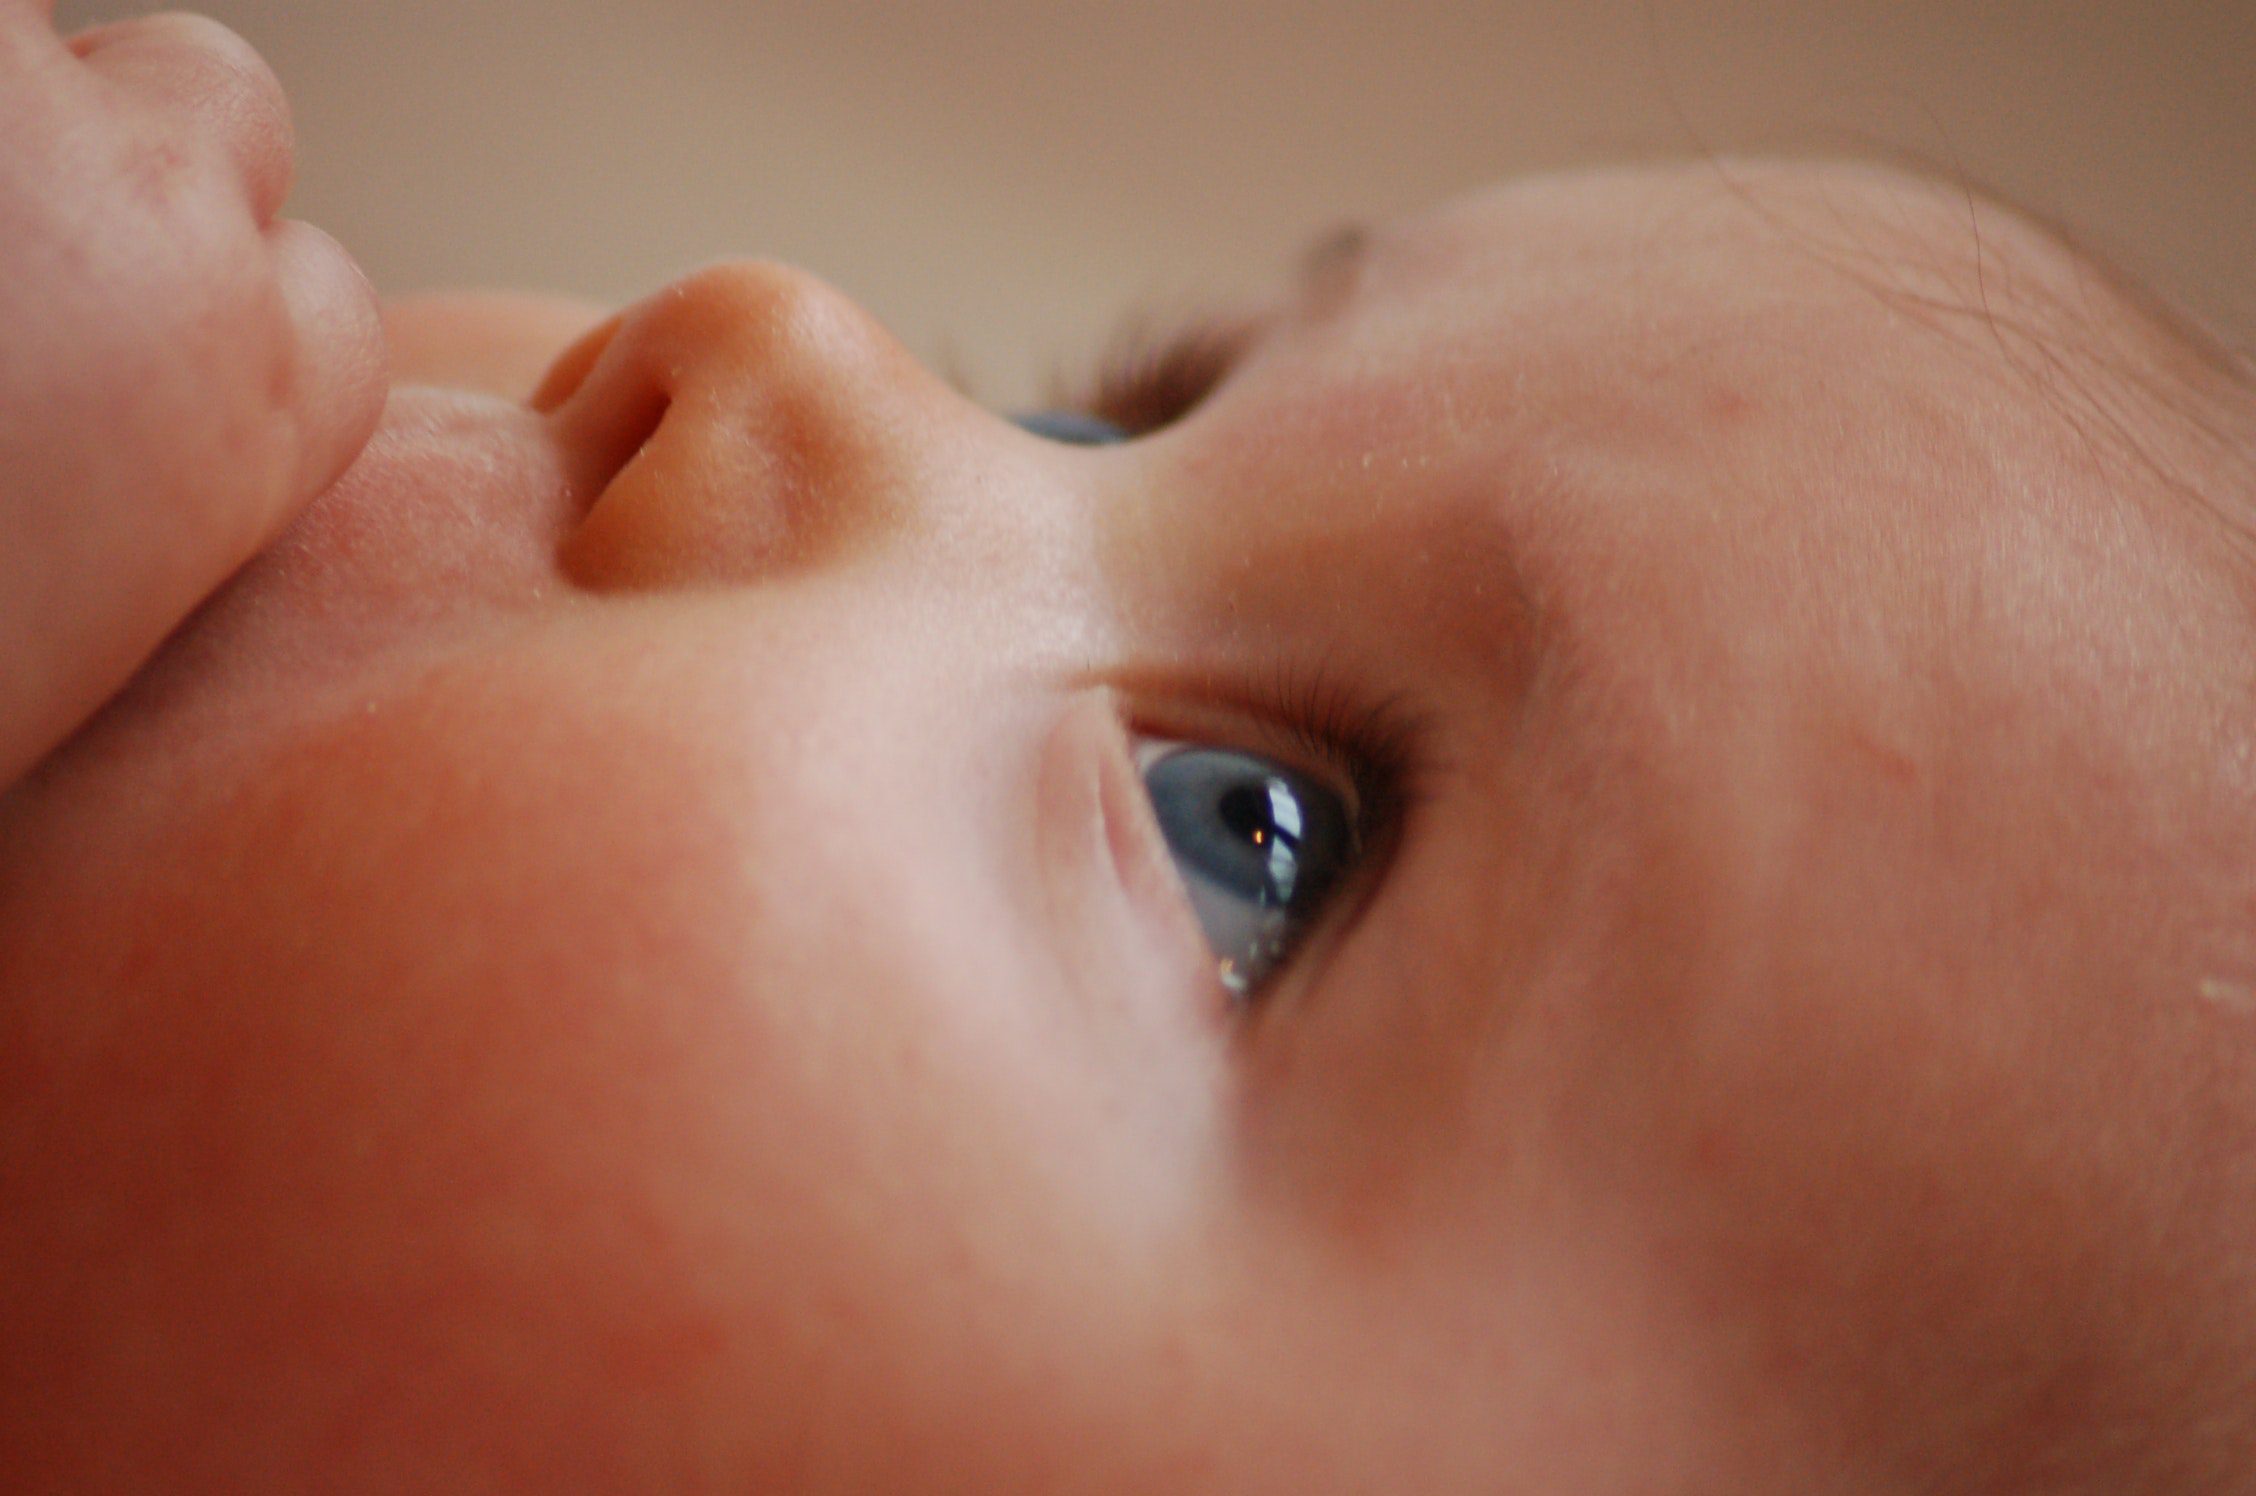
[535,264,963,589]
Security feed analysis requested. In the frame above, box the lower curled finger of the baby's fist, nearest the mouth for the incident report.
[266,219,386,519]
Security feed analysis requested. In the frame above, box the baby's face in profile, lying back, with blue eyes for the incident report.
[0,157,2256,1494]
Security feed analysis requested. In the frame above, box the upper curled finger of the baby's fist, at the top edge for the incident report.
[70,14,296,223]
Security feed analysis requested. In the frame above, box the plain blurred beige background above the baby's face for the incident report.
[59,0,2256,402]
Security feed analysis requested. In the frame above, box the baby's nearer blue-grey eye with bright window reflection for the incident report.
[1137,740,1358,997]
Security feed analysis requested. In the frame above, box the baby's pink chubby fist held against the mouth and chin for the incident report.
[0,0,384,792]
